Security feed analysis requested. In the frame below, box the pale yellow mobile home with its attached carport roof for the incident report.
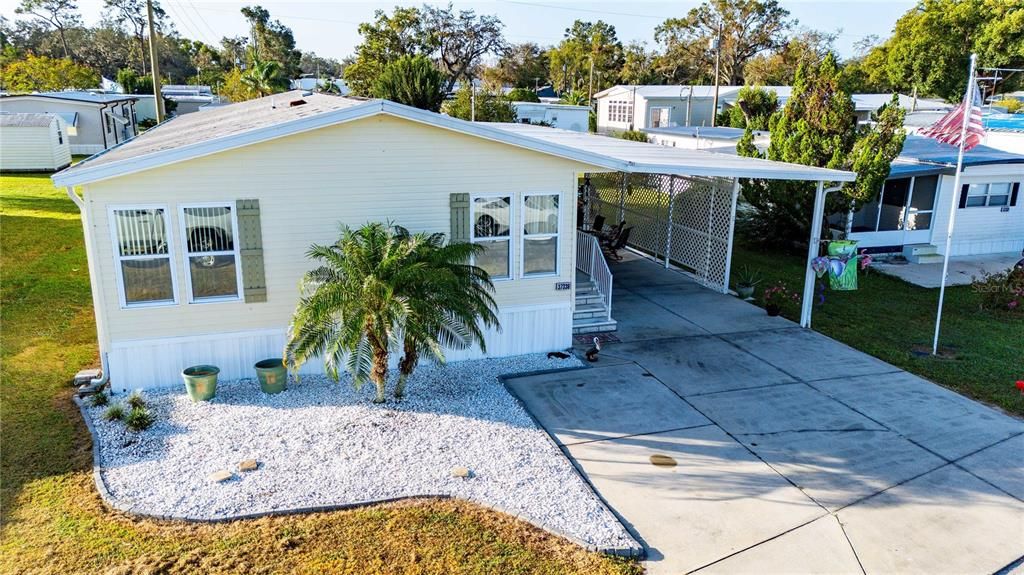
[53,91,853,389]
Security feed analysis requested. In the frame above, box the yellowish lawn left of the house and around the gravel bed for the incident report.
[0,170,640,575]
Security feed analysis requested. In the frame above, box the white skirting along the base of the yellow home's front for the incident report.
[108,304,572,392]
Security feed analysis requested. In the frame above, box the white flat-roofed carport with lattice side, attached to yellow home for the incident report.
[497,124,856,327]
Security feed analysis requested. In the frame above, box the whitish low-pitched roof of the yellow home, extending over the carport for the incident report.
[53,90,855,185]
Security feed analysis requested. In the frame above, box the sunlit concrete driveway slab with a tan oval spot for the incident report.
[567,427,825,575]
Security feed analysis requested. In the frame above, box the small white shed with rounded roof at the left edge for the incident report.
[0,114,71,172]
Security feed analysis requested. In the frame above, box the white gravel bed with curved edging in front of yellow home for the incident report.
[86,354,636,549]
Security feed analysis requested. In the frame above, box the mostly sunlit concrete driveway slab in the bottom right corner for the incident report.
[838,466,1024,574]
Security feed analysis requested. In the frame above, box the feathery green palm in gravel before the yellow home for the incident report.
[285,223,498,403]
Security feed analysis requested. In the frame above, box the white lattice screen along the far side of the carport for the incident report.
[589,172,734,291]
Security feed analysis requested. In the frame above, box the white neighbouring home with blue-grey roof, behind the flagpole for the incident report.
[831,135,1024,254]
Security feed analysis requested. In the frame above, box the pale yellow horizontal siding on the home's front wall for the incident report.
[82,116,602,349]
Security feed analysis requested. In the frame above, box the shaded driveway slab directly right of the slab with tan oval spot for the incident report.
[736,431,946,511]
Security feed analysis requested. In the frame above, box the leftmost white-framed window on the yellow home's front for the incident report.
[109,206,178,308]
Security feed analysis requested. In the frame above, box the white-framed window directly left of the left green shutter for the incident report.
[178,203,242,303]
